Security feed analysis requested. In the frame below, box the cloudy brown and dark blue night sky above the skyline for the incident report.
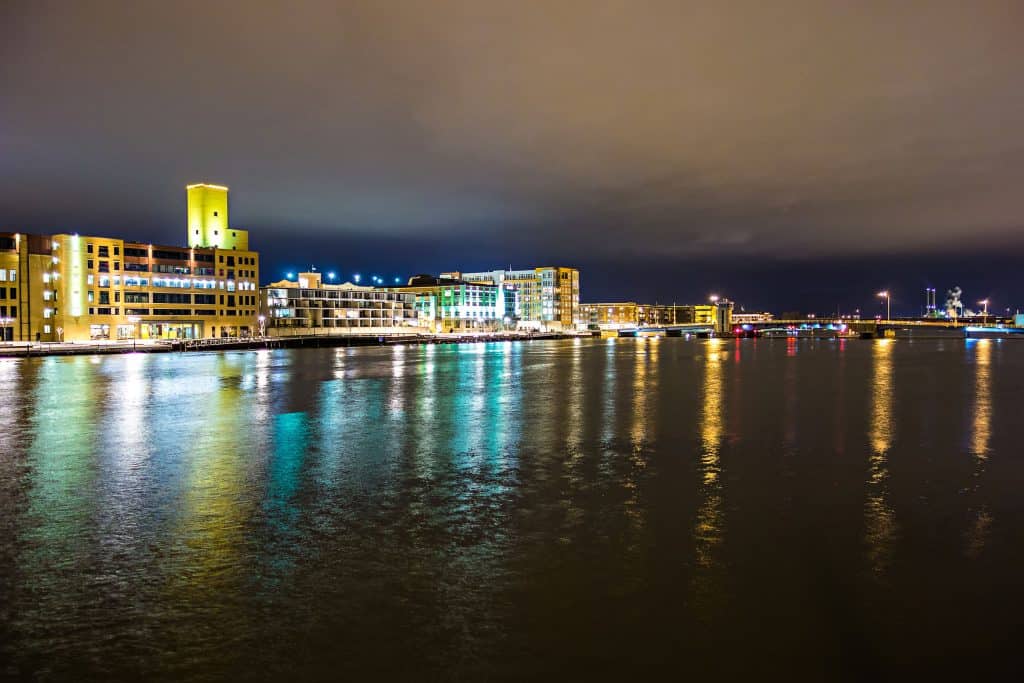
[0,0,1024,313]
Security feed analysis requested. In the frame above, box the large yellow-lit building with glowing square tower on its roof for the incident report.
[0,183,259,341]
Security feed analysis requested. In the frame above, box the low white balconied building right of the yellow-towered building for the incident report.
[260,272,424,337]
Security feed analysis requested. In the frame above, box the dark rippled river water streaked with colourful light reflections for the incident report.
[0,339,1024,681]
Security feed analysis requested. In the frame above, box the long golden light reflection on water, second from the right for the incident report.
[865,339,896,575]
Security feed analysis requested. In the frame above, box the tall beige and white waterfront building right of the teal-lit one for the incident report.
[441,266,584,331]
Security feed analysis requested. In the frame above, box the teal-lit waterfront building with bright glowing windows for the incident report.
[391,275,519,332]
